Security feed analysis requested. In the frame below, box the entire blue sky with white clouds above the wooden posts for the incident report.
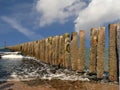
[0,0,120,46]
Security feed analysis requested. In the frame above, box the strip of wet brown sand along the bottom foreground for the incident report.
[0,80,119,90]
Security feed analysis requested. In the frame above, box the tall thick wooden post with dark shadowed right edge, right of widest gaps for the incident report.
[109,24,118,81]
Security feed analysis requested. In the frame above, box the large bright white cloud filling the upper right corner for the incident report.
[75,0,120,31]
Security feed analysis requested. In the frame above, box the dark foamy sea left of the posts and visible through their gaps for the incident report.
[0,48,120,81]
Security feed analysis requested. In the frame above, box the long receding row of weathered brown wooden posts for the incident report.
[9,24,120,81]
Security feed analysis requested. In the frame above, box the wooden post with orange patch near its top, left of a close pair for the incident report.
[89,28,97,74]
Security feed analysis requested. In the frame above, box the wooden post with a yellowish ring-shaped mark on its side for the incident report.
[64,33,71,68]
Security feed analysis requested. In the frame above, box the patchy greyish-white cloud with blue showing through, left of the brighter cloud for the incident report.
[36,0,86,26]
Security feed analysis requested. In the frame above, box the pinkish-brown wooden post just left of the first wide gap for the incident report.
[78,30,86,72]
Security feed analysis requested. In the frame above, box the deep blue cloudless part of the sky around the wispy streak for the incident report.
[0,0,74,46]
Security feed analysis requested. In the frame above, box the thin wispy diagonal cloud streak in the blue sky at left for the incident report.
[1,16,42,39]
